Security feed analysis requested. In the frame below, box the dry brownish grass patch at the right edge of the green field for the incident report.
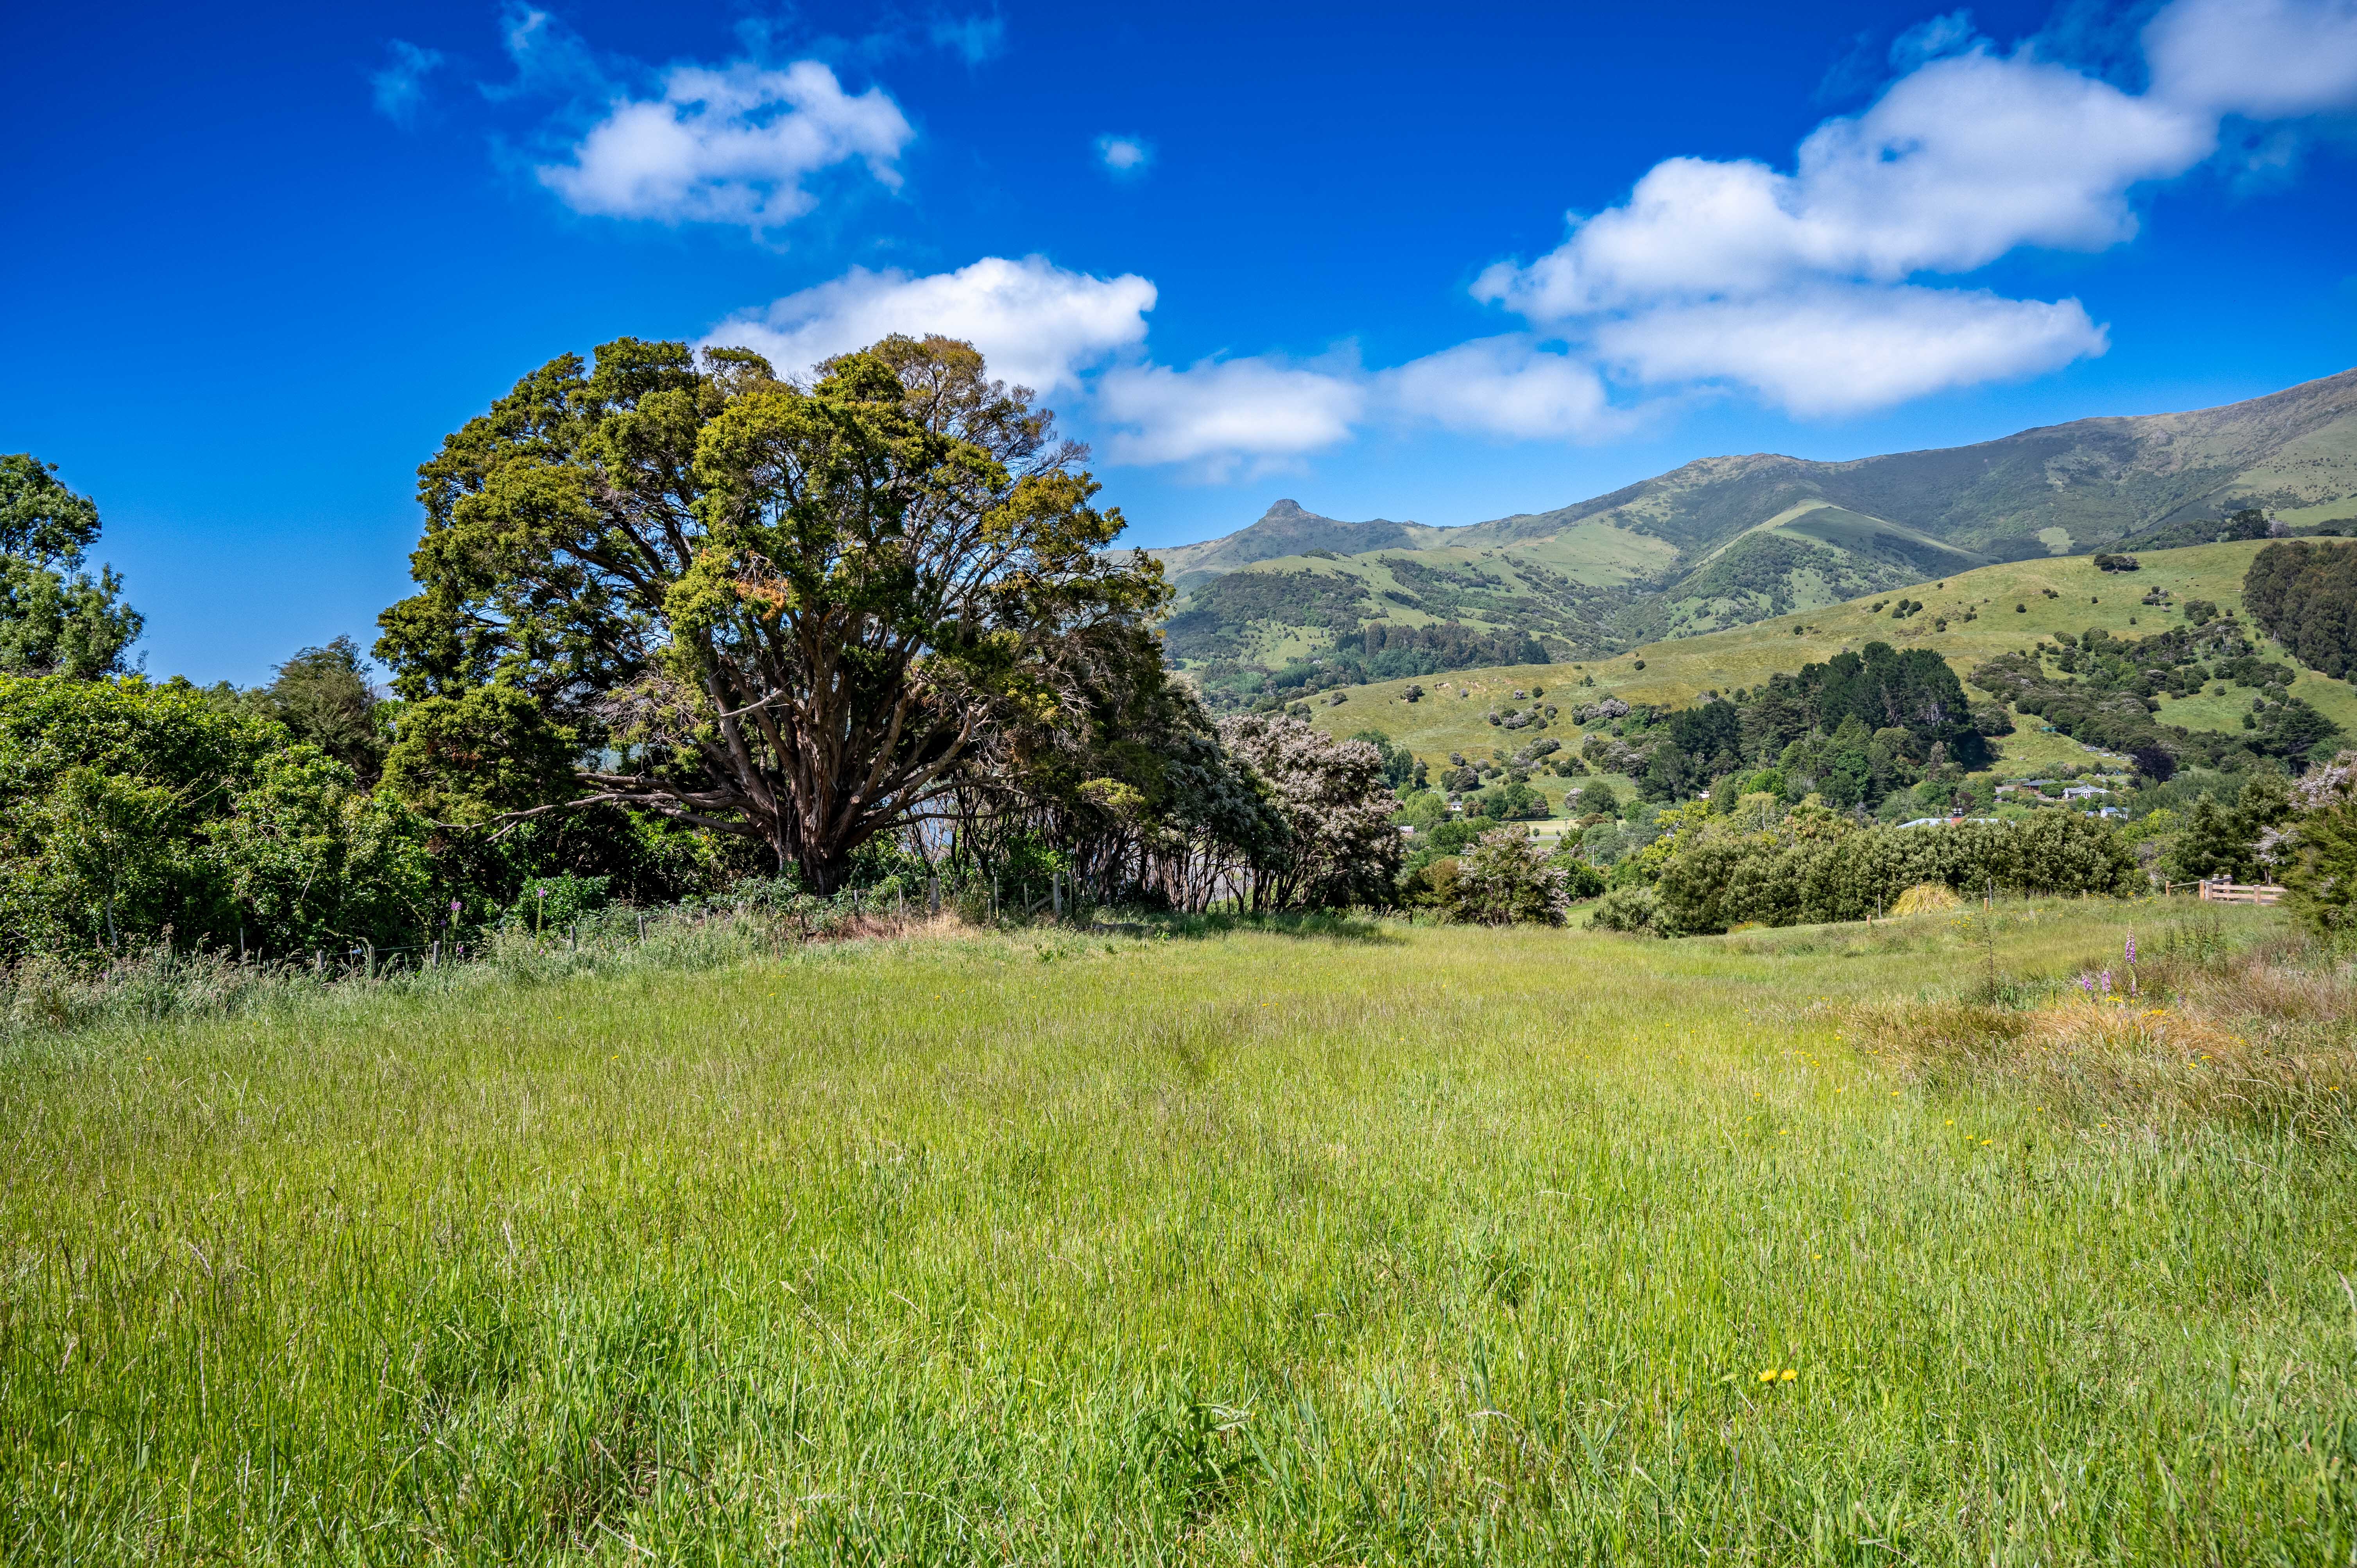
[1857,948,2357,1141]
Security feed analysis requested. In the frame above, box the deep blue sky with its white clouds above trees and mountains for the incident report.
[0,0,2357,684]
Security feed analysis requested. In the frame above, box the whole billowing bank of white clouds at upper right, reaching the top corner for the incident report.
[1473,0,2357,413]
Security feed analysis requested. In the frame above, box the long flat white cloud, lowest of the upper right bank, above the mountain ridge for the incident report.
[1596,285,2107,417]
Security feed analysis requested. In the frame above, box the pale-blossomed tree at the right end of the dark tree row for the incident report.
[1219,714,1400,910]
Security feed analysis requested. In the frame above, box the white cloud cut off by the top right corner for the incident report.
[2145,0,2357,120]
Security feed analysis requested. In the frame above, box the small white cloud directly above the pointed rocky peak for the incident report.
[1096,358,1367,476]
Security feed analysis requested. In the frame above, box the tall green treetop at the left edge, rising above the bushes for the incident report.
[0,453,146,679]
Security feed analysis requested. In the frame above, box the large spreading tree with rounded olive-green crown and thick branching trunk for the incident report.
[377,337,1164,891]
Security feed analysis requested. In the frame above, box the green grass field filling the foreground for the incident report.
[0,906,2357,1566]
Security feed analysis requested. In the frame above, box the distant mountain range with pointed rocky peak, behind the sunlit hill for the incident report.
[1155,370,2357,703]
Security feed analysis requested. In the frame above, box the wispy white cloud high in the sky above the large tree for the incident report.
[540,59,917,229]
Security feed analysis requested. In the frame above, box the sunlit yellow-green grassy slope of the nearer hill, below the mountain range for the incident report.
[1311,542,2357,797]
